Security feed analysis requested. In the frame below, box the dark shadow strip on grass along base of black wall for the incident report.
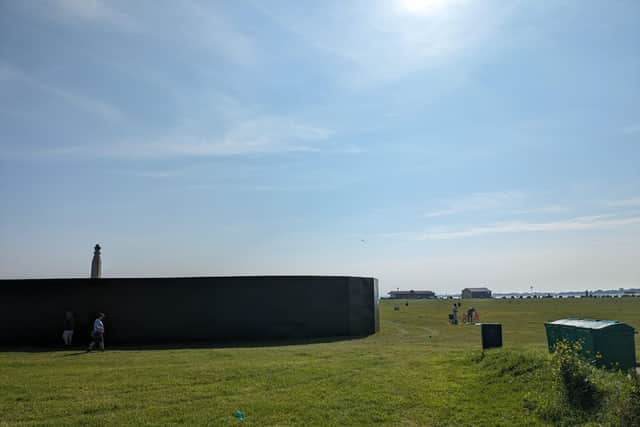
[0,336,365,357]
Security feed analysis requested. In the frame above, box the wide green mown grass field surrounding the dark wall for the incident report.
[0,298,640,426]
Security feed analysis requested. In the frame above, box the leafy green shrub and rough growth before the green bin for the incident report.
[467,341,640,427]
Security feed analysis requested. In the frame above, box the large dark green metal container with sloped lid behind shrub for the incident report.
[544,319,636,369]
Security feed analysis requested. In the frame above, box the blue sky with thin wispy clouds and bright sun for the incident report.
[0,0,640,293]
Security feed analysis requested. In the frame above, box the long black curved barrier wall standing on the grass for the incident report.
[0,276,379,346]
